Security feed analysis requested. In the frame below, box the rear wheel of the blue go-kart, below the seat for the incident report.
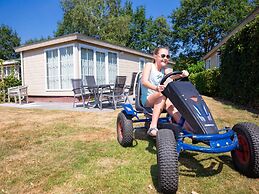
[117,111,133,147]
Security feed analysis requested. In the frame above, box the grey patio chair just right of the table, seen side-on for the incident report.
[99,76,127,109]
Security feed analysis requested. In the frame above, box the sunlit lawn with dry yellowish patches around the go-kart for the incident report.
[0,97,259,194]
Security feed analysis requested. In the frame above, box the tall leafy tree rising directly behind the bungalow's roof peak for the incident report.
[55,0,130,46]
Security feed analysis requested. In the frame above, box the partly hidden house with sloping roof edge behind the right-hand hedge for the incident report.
[203,7,259,69]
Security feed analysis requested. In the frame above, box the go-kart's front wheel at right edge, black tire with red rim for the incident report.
[231,122,259,178]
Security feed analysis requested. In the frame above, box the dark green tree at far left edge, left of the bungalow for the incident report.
[0,25,21,60]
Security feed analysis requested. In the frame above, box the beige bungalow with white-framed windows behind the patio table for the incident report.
[15,33,152,101]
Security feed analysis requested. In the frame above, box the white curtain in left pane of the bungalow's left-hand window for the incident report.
[46,49,59,89]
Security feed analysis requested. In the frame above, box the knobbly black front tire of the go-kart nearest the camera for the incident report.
[156,129,179,193]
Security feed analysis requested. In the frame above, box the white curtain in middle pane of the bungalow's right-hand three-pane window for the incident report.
[96,52,105,84]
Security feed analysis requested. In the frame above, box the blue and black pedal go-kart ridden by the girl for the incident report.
[117,71,259,193]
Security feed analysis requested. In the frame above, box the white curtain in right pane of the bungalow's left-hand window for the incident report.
[60,46,74,89]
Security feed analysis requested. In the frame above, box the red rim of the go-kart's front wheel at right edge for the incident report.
[236,134,250,165]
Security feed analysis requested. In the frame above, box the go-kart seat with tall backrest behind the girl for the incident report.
[135,72,166,117]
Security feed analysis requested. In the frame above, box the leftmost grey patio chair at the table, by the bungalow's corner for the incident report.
[71,79,90,107]
